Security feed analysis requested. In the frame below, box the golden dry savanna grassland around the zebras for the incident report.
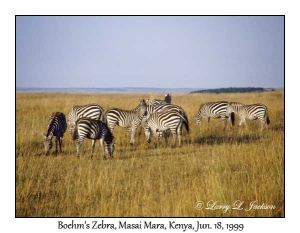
[16,91,285,217]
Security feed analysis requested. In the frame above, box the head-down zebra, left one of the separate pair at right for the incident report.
[195,101,234,130]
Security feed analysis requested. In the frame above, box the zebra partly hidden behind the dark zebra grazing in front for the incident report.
[69,104,106,134]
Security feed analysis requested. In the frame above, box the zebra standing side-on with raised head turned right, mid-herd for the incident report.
[106,99,147,145]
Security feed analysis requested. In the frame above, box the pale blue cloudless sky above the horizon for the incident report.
[16,16,284,88]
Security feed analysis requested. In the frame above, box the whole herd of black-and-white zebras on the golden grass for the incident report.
[43,94,270,158]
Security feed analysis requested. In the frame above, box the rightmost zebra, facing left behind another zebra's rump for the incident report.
[227,102,270,130]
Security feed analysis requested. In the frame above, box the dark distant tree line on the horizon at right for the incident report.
[190,87,275,94]
